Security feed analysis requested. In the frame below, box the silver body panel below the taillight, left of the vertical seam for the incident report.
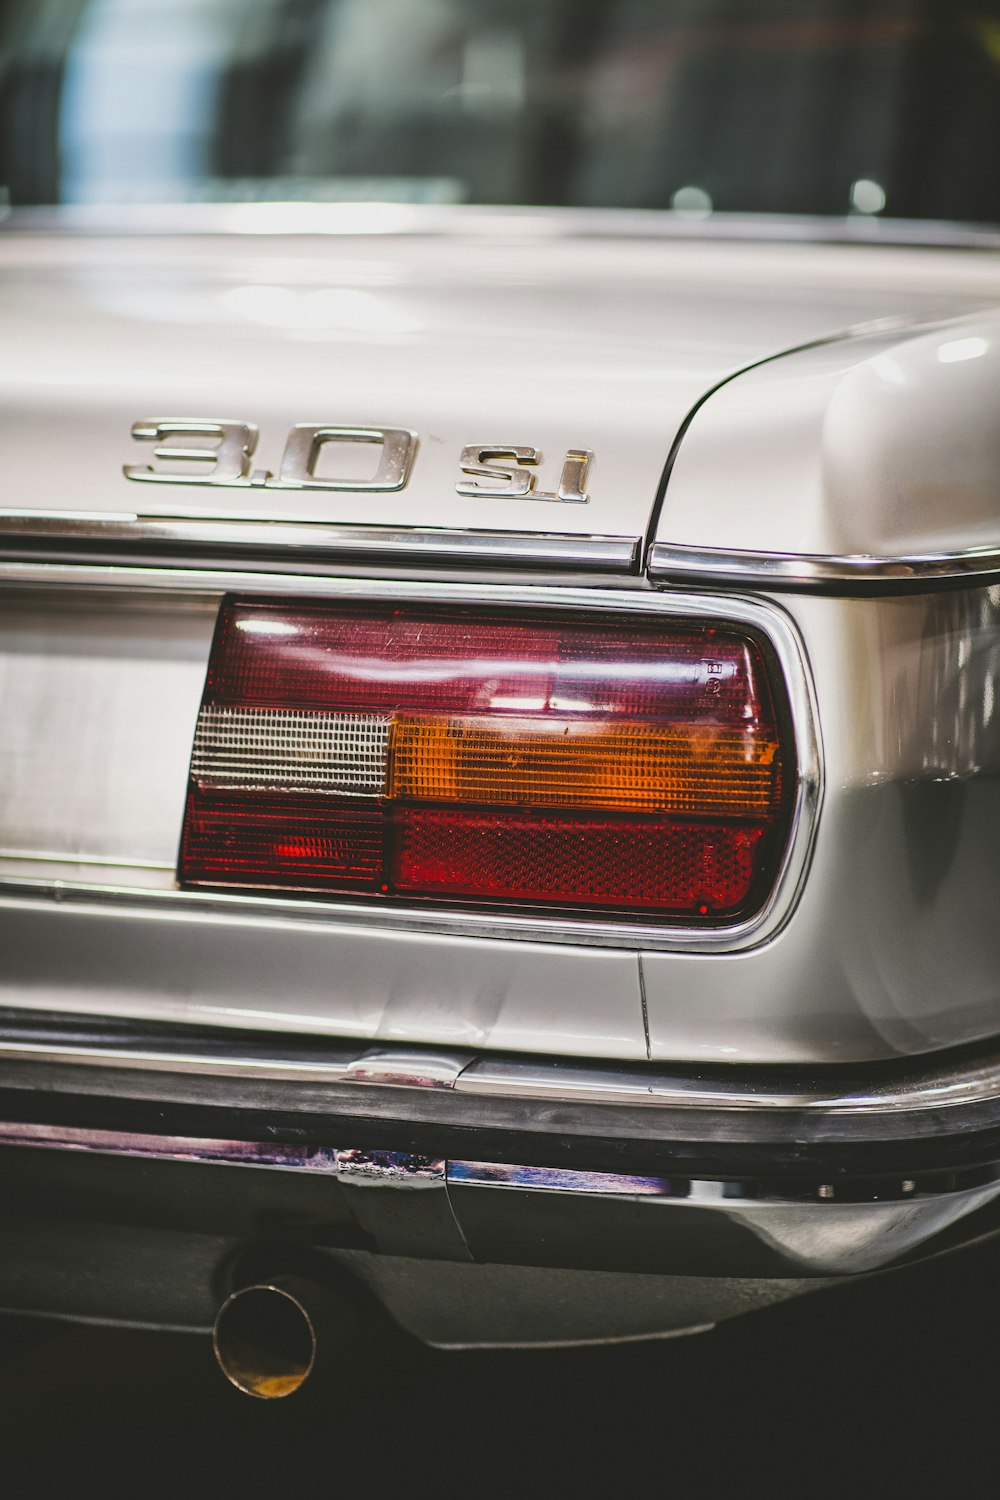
[0,896,646,1058]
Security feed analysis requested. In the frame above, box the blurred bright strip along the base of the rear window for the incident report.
[7,201,1000,249]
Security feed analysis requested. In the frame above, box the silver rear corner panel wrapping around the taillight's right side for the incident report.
[643,590,1000,1062]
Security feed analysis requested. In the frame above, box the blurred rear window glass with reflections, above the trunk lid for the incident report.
[0,0,1000,222]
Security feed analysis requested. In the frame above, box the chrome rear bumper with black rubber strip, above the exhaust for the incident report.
[0,1013,1000,1343]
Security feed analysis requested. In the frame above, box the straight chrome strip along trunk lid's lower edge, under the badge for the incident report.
[0,510,642,573]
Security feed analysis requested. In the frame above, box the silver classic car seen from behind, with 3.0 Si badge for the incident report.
[0,0,1000,1397]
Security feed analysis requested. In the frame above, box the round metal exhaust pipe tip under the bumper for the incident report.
[211,1277,360,1401]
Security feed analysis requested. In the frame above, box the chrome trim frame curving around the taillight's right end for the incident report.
[0,563,823,953]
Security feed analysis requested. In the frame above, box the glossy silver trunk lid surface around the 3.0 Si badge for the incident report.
[0,228,1000,545]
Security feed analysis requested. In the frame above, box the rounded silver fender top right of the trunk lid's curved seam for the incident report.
[657,312,1000,558]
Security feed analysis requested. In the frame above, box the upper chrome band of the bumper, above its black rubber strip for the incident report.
[0,1013,1000,1119]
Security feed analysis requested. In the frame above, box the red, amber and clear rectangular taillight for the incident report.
[180,602,795,923]
